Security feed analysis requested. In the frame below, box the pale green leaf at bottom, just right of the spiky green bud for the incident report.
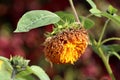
[30,66,50,80]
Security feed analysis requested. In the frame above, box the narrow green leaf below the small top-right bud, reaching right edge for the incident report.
[101,12,120,25]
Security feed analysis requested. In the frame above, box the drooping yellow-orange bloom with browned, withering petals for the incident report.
[44,29,88,64]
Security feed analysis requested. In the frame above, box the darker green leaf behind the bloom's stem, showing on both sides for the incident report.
[56,11,94,29]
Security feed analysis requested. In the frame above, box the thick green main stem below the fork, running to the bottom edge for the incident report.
[98,47,115,80]
